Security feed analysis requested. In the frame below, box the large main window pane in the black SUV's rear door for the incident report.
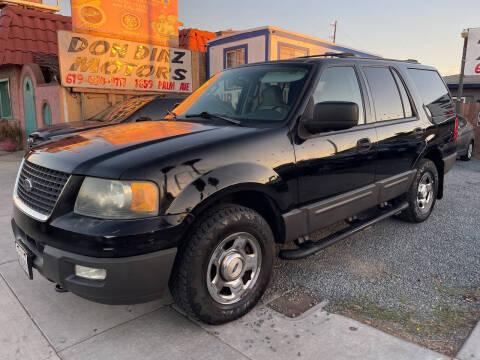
[364,67,404,121]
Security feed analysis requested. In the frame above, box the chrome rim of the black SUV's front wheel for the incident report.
[207,232,262,305]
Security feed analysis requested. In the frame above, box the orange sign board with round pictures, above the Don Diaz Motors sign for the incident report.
[71,0,179,46]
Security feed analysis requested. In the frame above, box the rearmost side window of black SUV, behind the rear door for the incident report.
[408,69,455,123]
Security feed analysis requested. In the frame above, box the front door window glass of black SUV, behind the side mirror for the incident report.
[313,66,365,125]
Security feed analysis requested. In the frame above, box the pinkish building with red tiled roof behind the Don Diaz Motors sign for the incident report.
[0,1,211,145]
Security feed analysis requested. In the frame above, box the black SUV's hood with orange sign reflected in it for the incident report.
[26,121,252,178]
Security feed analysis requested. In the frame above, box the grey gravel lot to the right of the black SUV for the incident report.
[267,160,480,355]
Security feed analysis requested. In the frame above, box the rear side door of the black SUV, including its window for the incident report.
[362,66,426,201]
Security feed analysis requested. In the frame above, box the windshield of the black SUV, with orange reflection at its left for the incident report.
[174,64,310,123]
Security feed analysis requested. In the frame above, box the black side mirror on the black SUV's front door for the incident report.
[302,101,359,134]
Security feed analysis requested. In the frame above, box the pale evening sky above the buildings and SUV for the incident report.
[52,0,480,75]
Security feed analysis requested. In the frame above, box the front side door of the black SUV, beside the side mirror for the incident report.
[295,65,377,231]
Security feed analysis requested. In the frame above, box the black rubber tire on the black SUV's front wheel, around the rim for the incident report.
[170,204,275,325]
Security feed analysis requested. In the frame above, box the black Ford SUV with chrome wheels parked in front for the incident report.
[12,54,458,324]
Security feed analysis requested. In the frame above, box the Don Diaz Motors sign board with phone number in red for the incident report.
[58,31,192,93]
